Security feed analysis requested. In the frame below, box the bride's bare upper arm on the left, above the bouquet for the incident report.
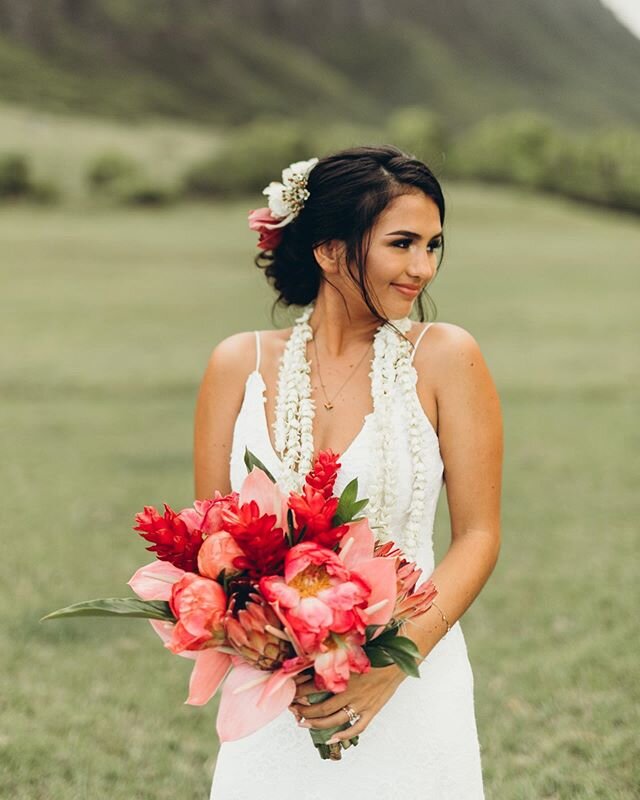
[193,331,255,500]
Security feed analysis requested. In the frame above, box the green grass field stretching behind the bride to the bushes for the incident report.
[0,185,640,800]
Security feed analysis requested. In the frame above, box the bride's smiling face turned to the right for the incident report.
[352,191,442,319]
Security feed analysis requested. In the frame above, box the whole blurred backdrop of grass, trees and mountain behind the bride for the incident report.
[0,0,640,800]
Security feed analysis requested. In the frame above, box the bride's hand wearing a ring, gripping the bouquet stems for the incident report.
[289,665,407,744]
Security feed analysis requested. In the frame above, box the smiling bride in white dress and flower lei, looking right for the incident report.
[194,145,503,800]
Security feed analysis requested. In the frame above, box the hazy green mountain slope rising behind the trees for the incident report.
[0,0,640,128]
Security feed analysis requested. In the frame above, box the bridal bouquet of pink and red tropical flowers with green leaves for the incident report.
[43,450,436,759]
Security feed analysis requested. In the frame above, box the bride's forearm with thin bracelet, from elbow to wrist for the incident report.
[401,530,500,658]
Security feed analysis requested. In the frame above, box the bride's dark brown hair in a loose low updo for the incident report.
[255,144,445,321]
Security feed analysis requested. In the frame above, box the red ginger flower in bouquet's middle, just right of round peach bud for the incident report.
[222,500,287,579]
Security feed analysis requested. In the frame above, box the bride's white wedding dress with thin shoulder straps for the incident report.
[211,326,484,800]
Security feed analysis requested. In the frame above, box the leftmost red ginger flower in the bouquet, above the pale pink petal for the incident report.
[133,503,203,572]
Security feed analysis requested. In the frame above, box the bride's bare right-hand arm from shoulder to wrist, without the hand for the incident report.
[403,323,503,657]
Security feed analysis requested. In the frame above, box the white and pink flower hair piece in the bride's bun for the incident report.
[248,158,318,250]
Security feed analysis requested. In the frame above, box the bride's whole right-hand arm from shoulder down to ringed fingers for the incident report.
[291,323,503,741]
